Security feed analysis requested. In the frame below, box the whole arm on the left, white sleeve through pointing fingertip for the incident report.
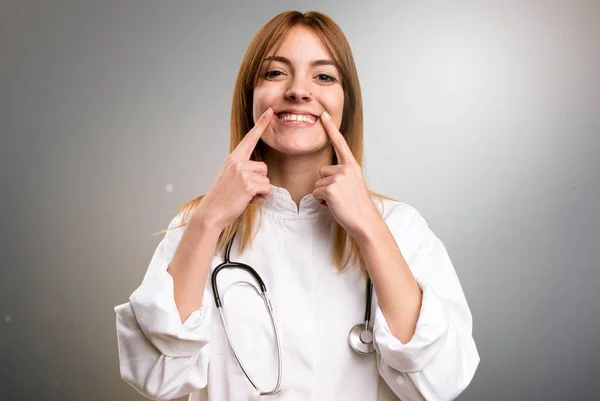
[115,108,273,399]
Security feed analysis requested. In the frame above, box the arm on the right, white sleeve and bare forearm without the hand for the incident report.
[360,204,479,401]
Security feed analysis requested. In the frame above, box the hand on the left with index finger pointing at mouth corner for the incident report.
[193,108,273,229]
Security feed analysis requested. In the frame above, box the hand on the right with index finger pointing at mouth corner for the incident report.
[313,112,382,239]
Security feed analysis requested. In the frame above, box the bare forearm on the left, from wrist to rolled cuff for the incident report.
[167,212,221,322]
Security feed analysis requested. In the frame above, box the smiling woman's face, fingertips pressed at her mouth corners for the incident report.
[253,27,344,155]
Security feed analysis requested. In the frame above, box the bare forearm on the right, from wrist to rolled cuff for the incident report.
[356,217,422,344]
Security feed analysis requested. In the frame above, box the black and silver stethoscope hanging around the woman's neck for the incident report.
[211,233,375,396]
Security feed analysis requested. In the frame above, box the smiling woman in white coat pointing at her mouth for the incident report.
[115,12,479,401]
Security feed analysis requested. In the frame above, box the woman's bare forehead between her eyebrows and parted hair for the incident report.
[268,26,331,62]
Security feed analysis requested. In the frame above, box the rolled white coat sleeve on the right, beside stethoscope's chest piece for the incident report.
[374,203,479,401]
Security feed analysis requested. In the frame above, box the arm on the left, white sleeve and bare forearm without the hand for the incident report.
[115,211,216,400]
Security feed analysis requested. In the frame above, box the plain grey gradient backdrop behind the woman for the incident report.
[0,0,600,401]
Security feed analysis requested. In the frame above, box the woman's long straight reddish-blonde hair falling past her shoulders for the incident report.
[159,11,392,272]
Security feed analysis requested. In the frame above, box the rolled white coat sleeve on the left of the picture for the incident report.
[115,213,212,400]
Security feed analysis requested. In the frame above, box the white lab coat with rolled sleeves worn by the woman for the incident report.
[115,185,479,401]
